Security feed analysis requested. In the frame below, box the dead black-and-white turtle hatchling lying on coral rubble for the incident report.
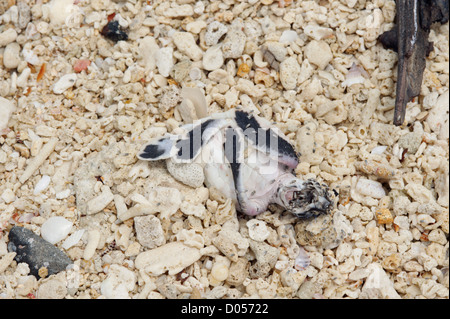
[138,109,333,219]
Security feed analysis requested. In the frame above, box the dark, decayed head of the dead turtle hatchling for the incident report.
[277,178,333,219]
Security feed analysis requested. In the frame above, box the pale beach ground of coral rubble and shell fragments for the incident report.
[0,0,449,299]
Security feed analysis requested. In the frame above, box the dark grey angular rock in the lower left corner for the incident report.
[8,226,73,279]
